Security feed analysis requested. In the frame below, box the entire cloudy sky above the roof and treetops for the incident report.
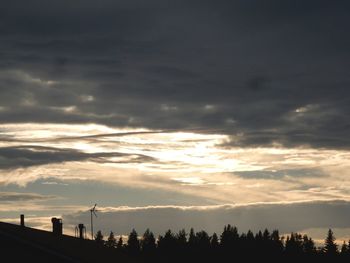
[0,0,350,244]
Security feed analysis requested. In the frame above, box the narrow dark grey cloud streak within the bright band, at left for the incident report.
[0,146,155,169]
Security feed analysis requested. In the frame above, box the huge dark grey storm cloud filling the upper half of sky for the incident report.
[0,0,350,148]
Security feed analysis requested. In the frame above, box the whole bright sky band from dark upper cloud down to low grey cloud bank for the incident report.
[0,123,350,240]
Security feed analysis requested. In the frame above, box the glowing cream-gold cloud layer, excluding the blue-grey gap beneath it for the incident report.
[0,124,350,204]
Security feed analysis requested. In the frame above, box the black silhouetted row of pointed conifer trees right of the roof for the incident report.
[95,225,350,262]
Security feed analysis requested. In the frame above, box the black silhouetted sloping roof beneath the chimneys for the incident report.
[0,222,139,263]
